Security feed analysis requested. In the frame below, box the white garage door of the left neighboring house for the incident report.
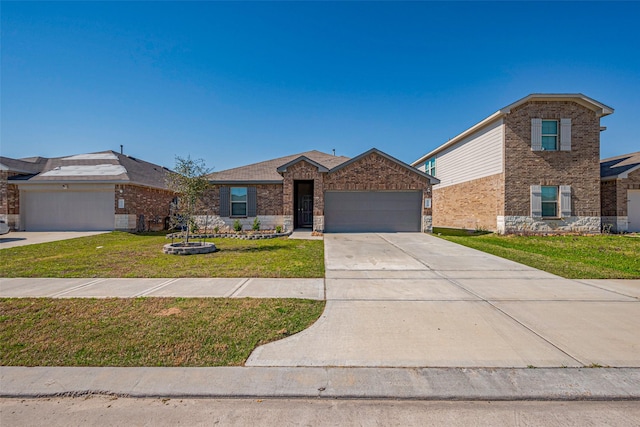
[20,187,115,231]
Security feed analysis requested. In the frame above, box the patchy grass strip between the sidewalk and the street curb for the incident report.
[0,298,324,366]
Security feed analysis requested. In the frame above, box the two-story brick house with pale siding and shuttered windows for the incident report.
[412,94,613,233]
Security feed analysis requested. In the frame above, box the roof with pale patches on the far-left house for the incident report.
[2,151,170,189]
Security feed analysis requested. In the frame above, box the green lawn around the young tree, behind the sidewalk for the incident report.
[0,232,324,277]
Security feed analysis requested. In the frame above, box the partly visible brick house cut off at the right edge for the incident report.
[600,151,640,232]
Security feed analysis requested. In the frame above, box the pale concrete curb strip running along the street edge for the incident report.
[0,367,640,401]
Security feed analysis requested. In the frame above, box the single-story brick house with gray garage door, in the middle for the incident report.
[205,149,438,232]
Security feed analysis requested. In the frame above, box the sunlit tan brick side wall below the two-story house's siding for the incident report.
[433,173,504,231]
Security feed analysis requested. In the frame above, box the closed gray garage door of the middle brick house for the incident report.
[325,191,422,232]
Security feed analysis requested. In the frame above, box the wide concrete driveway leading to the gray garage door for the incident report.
[247,233,640,367]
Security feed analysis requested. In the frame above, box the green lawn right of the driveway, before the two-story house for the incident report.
[433,228,640,279]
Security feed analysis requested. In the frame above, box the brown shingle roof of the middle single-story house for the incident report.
[208,150,349,183]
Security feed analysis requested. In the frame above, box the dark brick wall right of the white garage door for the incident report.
[114,184,175,230]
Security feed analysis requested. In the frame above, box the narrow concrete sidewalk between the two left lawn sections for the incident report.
[0,278,325,300]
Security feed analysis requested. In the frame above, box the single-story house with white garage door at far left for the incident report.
[0,151,175,231]
